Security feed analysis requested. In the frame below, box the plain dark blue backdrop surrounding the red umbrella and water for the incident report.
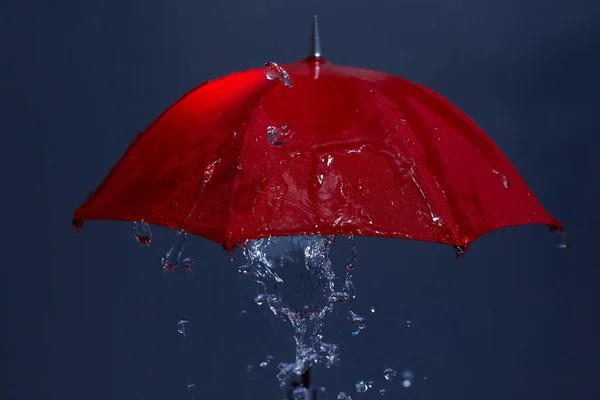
[0,0,600,400]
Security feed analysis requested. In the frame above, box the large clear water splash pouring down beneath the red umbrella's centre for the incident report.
[238,235,356,384]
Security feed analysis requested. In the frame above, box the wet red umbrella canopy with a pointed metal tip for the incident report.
[73,17,562,252]
